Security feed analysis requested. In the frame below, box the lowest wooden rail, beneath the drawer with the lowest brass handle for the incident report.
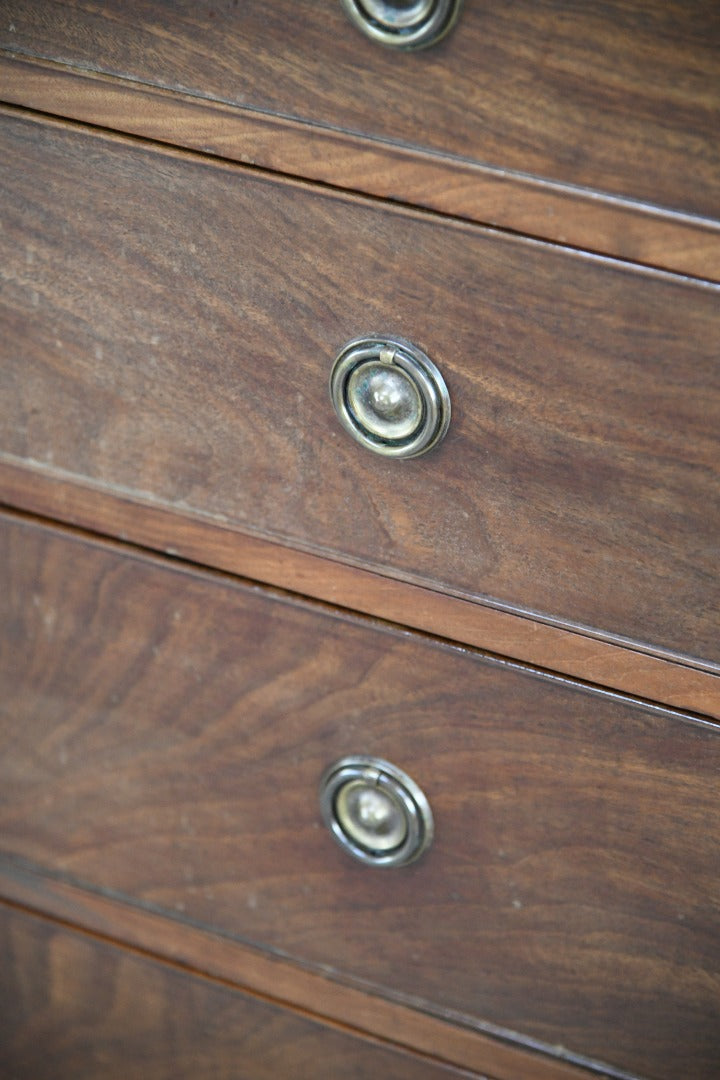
[0,855,612,1080]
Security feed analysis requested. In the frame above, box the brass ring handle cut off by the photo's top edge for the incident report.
[341,0,461,49]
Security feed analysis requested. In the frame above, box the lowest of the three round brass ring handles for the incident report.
[320,756,434,866]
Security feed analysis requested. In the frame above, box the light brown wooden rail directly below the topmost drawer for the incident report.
[0,53,720,282]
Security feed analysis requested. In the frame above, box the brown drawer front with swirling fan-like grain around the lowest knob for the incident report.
[0,521,720,1080]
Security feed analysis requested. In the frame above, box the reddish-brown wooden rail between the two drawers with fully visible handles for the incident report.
[0,460,720,720]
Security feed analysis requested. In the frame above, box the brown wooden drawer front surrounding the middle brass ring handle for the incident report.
[0,111,720,661]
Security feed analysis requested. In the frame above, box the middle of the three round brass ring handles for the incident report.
[330,337,450,458]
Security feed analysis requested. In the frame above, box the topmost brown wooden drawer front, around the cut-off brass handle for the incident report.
[0,0,720,223]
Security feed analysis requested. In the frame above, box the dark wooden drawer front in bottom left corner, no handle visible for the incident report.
[0,905,470,1080]
